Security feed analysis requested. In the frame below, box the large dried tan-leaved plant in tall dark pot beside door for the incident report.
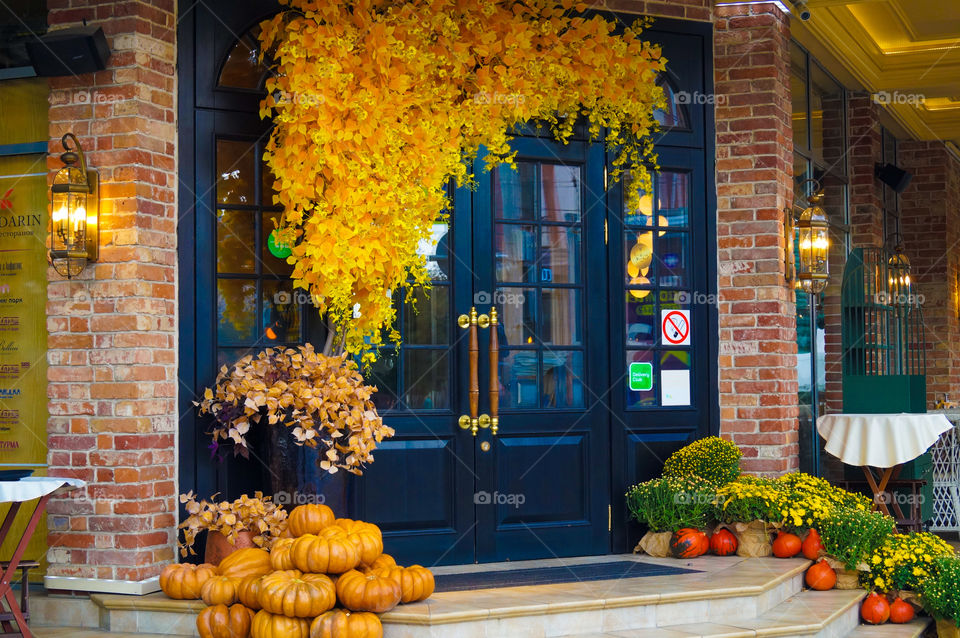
[195,344,394,474]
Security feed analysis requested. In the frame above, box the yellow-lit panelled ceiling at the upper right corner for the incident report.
[791,0,960,151]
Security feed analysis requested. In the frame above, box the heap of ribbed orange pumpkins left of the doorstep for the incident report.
[160,505,434,638]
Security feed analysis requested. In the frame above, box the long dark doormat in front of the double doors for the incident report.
[435,560,697,591]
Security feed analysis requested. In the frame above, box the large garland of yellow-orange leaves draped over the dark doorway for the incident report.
[260,0,666,361]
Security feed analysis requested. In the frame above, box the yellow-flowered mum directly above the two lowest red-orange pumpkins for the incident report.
[860,532,955,591]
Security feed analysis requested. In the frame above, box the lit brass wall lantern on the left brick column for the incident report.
[50,133,100,279]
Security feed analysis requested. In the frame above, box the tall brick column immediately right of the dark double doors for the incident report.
[714,3,799,474]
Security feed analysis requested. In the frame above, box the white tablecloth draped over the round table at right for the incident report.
[817,414,953,467]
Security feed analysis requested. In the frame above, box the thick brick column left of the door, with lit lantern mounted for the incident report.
[47,0,177,589]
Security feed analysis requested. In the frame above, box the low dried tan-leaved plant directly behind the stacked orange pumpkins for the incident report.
[180,491,287,556]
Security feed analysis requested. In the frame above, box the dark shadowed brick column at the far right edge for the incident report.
[897,141,960,408]
